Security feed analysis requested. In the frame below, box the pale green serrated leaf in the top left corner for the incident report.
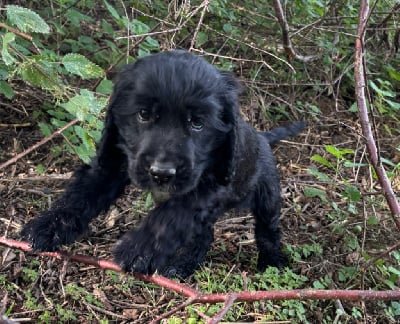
[6,5,50,34]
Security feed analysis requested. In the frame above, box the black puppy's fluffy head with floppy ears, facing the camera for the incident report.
[109,51,239,196]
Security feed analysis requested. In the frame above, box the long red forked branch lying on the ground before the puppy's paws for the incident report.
[0,237,400,323]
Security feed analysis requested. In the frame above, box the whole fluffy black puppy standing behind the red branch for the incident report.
[22,51,305,277]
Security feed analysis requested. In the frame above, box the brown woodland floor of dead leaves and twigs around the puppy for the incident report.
[0,83,400,323]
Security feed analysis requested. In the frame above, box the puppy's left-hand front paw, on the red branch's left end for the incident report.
[21,210,85,251]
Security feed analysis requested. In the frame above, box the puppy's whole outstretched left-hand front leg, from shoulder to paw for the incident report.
[21,115,129,251]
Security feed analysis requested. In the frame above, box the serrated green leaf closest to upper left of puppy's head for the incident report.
[62,53,104,79]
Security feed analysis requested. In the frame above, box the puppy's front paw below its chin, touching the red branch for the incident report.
[114,230,173,274]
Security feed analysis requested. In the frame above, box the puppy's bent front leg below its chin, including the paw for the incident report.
[114,191,223,277]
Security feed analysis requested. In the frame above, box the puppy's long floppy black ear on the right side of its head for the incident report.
[220,72,242,184]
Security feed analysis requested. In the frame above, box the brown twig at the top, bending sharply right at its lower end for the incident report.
[272,0,318,62]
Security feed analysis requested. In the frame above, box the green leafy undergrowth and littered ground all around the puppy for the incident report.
[0,1,400,323]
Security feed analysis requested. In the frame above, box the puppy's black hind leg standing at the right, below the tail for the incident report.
[252,179,288,271]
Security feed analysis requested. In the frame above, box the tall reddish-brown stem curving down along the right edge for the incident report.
[354,0,400,230]
